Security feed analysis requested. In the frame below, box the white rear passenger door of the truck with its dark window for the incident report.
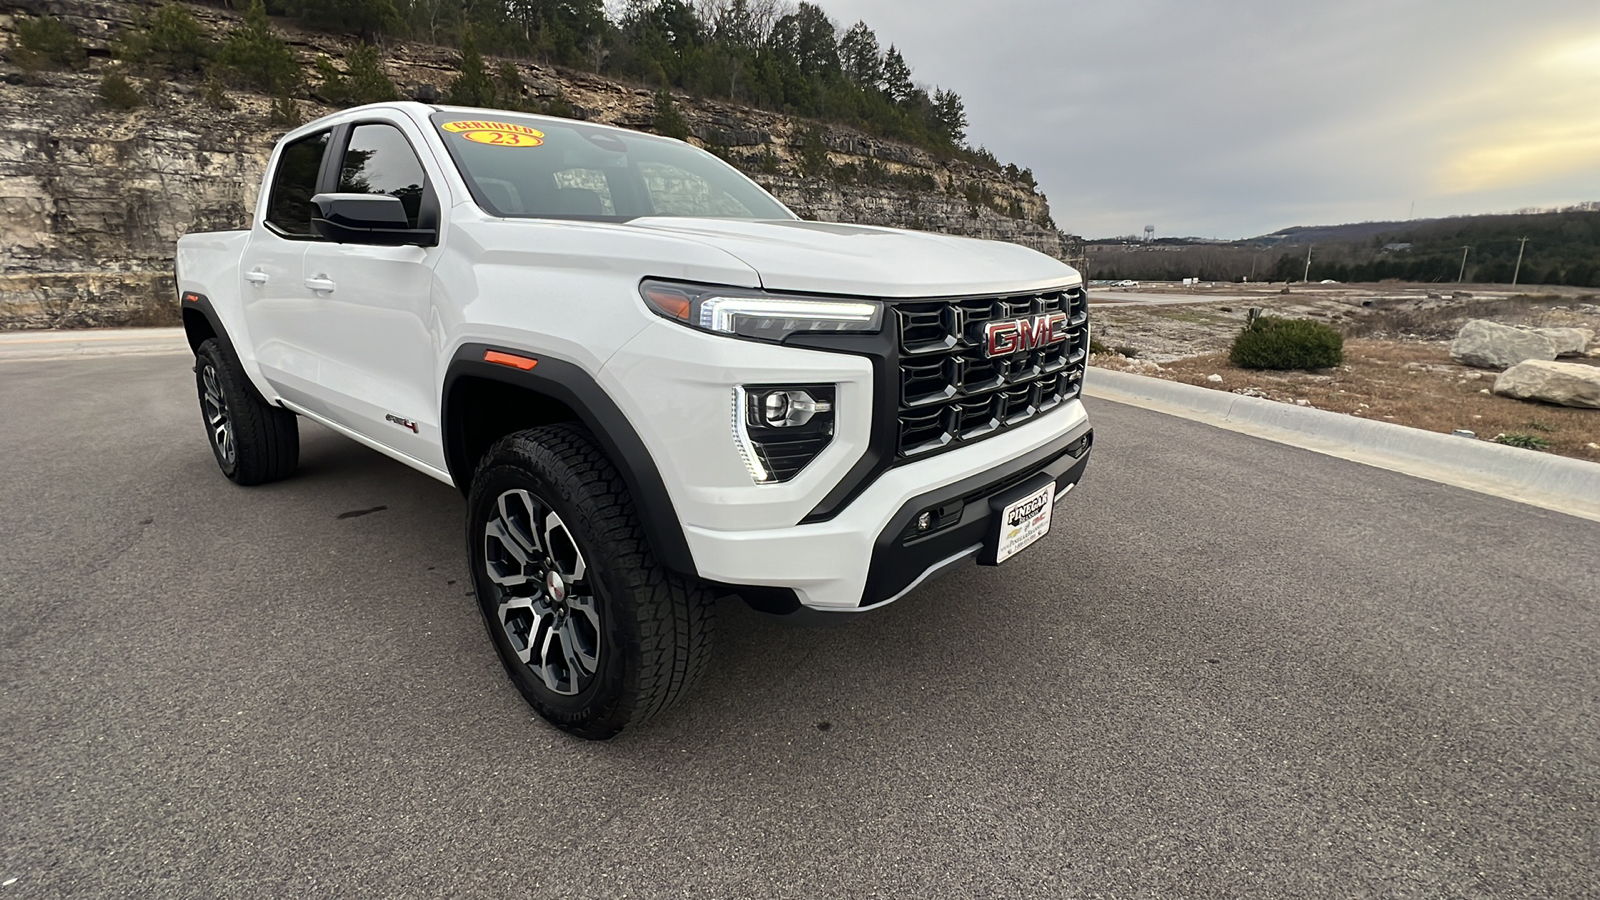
[238,130,333,413]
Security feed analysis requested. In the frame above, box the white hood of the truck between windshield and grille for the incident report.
[629,216,1078,298]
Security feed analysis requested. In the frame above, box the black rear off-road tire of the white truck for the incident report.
[195,338,299,487]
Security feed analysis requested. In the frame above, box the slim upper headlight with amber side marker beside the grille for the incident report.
[638,279,883,341]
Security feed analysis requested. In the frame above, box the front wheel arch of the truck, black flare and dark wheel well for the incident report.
[440,344,699,577]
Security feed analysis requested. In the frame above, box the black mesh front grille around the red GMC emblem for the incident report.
[893,287,1090,460]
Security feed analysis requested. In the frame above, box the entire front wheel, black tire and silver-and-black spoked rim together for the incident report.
[467,424,715,740]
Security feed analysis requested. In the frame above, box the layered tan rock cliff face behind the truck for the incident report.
[0,0,1082,328]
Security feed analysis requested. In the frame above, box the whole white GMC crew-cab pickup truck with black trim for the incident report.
[176,102,1093,738]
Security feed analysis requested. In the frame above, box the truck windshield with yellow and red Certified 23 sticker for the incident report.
[432,109,795,221]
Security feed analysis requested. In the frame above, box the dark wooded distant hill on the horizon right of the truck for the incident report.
[1088,203,1600,287]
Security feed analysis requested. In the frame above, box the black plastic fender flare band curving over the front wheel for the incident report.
[440,343,699,577]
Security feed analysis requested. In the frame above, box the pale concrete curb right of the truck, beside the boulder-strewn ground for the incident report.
[1085,361,1600,522]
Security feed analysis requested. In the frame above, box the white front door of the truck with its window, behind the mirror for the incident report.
[302,119,445,469]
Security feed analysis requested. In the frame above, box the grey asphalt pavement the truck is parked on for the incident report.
[0,354,1600,900]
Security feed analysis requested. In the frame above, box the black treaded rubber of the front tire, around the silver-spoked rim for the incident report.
[467,424,715,740]
